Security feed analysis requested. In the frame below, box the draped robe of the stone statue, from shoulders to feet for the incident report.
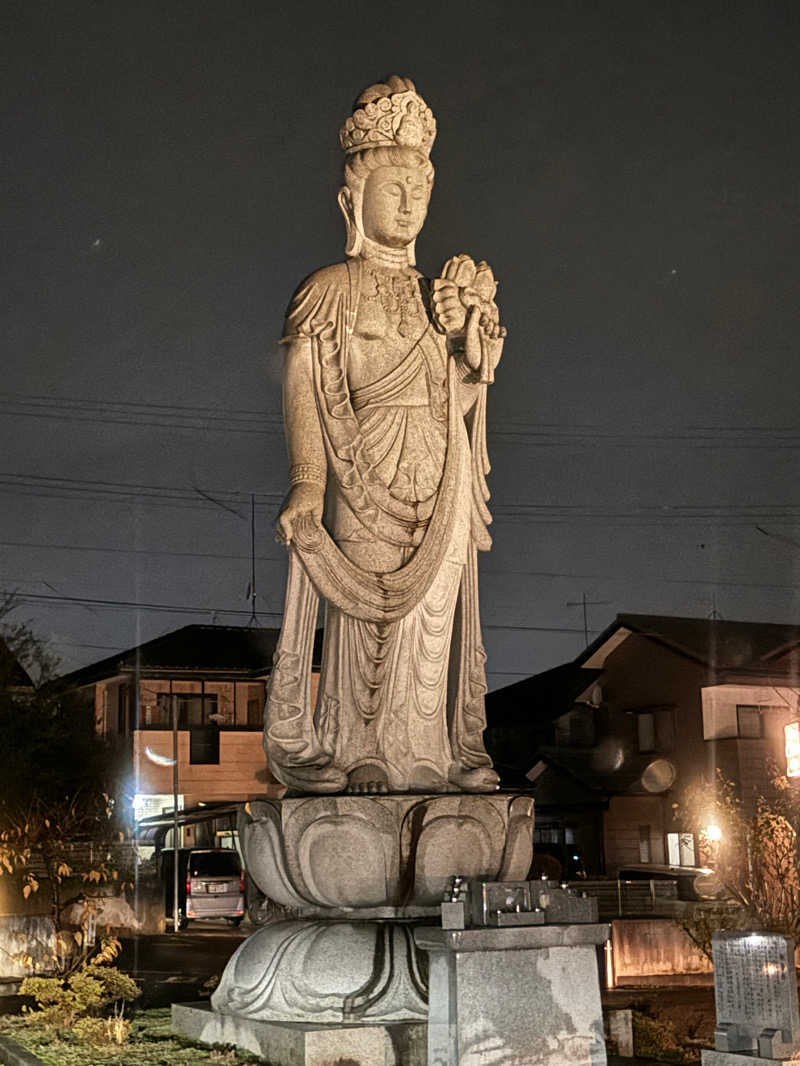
[265,260,499,792]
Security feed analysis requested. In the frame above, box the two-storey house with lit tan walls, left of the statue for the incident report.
[60,625,319,843]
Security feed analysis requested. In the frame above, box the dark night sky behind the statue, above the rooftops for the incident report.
[0,0,800,688]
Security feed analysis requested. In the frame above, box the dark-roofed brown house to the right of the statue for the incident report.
[486,614,800,874]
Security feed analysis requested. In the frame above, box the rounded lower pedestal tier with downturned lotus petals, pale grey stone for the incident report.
[211,919,428,1024]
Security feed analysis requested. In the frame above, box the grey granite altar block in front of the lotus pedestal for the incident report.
[414,923,608,1066]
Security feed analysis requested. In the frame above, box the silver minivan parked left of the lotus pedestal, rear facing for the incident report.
[159,847,244,928]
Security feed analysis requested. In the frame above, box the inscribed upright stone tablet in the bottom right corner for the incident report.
[703,933,800,1066]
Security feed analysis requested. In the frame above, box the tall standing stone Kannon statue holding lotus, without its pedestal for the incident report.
[265,76,506,793]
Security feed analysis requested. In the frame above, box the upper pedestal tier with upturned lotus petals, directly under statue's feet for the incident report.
[239,792,533,918]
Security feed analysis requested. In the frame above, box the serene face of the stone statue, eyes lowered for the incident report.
[362,166,431,248]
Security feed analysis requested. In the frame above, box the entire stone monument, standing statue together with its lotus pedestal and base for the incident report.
[174,76,533,1066]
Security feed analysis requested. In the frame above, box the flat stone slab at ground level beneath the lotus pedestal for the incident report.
[172,1003,428,1066]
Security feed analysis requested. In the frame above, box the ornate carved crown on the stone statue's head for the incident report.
[339,75,436,156]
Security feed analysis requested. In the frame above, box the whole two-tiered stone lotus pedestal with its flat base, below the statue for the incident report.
[174,793,533,1066]
